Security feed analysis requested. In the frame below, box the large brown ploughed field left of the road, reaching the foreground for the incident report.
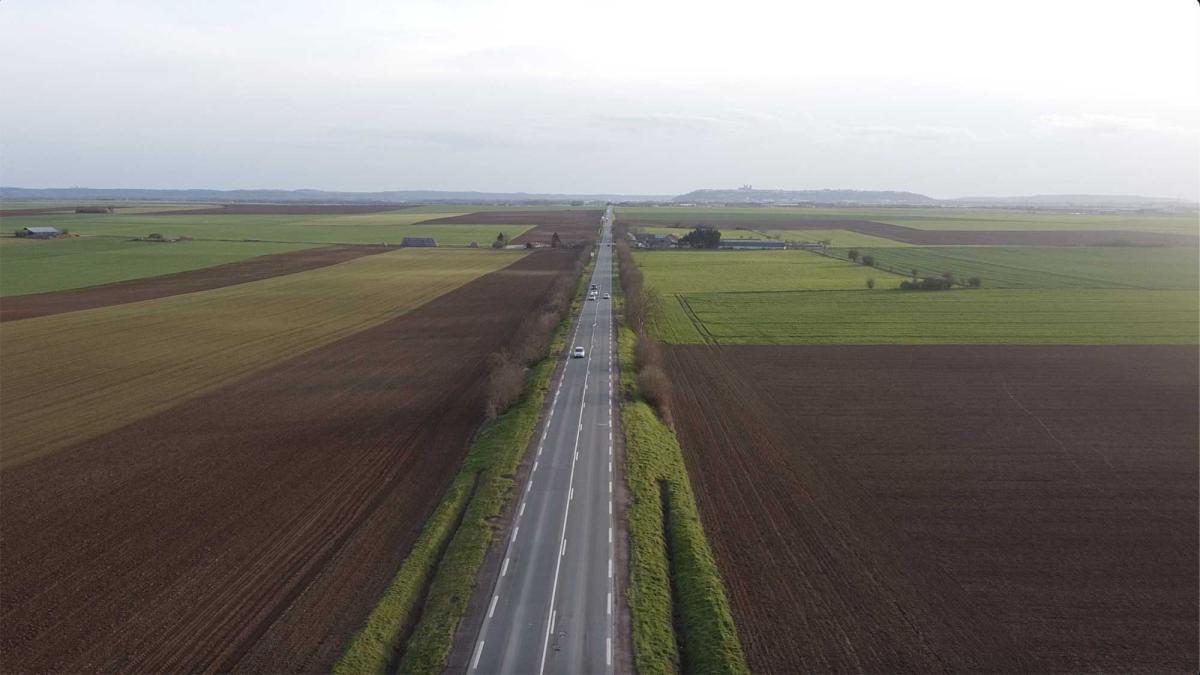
[0,251,570,673]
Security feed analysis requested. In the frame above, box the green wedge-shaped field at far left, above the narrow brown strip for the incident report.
[0,237,312,295]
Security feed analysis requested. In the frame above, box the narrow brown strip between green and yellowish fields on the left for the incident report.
[0,246,392,322]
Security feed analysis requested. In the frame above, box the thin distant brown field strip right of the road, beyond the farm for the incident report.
[622,219,1200,246]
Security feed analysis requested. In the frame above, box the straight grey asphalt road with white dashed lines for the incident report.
[470,208,616,674]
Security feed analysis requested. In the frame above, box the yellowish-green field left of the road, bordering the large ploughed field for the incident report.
[0,251,515,466]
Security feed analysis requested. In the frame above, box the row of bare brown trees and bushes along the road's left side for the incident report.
[484,244,588,419]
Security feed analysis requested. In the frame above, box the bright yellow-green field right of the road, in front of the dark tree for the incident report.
[634,251,900,342]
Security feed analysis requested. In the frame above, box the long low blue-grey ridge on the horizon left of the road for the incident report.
[0,187,671,204]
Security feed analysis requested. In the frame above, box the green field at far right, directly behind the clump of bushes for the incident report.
[830,246,1200,289]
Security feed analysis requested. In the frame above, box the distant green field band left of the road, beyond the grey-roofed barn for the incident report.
[2,207,533,246]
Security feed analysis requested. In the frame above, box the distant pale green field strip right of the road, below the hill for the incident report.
[618,207,1200,234]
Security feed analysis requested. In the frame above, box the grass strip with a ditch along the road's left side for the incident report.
[334,249,592,675]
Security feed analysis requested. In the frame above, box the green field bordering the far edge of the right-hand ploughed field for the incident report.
[670,288,1200,345]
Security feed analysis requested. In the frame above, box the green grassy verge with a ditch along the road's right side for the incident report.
[614,243,749,675]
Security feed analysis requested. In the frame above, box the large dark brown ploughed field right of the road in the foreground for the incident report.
[666,346,1200,673]
